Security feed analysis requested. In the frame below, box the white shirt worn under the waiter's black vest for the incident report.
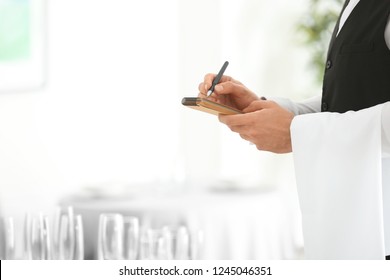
[275,0,390,157]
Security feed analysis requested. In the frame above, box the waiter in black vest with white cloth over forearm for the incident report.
[199,0,390,259]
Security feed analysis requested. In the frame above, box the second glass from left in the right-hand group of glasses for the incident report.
[123,217,140,260]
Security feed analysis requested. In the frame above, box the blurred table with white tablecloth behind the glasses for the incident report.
[61,190,303,260]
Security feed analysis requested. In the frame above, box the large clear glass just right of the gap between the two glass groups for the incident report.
[99,214,123,260]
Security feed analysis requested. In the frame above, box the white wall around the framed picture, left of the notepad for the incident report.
[0,0,180,215]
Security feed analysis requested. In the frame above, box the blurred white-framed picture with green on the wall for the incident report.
[0,0,46,92]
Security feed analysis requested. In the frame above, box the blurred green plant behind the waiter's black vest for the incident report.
[298,0,344,82]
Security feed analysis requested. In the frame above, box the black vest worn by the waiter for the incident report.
[321,0,390,113]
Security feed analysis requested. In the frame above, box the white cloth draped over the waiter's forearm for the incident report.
[291,103,390,259]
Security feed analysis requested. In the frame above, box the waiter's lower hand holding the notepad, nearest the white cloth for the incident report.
[219,100,294,153]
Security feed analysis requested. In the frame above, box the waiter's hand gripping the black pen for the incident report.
[199,74,259,110]
